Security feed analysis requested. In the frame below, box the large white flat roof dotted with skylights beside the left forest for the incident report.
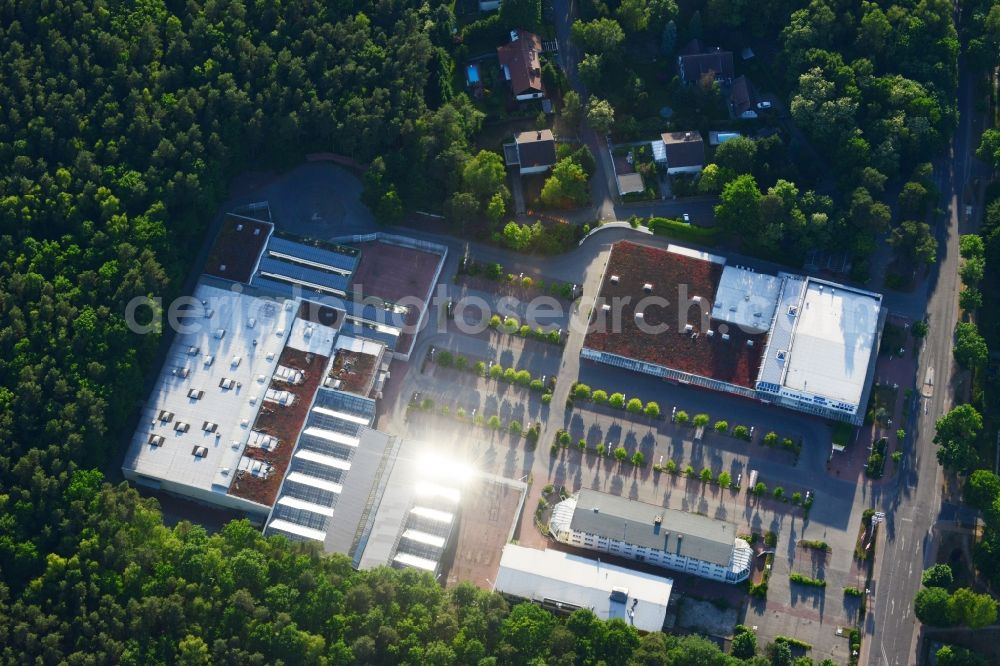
[122,278,297,493]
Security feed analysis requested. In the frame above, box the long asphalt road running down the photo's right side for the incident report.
[865,53,988,666]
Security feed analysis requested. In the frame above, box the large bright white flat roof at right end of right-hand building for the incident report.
[784,278,882,405]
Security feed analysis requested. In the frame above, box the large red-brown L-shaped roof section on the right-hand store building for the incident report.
[583,241,767,387]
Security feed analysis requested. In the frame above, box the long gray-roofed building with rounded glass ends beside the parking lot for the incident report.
[549,488,753,583]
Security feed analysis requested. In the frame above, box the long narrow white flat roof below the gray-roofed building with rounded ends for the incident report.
[495,544,674,631]
